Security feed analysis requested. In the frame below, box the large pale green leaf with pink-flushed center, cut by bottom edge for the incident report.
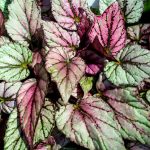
[56,97,125,150]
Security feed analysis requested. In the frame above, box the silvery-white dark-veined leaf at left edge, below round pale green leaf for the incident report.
[0,82,22,113]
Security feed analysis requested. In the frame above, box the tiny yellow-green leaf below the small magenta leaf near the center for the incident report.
[80,76,93,94]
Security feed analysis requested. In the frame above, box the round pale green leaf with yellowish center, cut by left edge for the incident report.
[0,43,32,82]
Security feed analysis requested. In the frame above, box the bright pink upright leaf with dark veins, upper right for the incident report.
[89,2,126,56]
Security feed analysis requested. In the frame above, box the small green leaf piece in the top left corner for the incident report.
[0,0,12,17]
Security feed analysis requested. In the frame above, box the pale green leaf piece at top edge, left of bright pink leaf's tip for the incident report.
[99,0,116,14]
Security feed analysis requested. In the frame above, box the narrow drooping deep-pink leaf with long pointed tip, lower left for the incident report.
[17,79,47,148]
